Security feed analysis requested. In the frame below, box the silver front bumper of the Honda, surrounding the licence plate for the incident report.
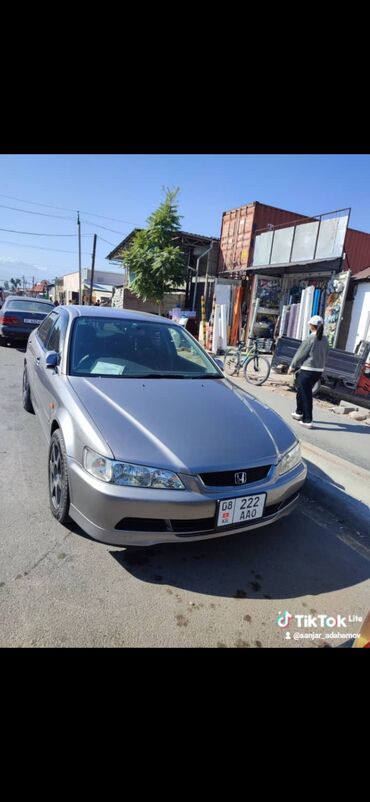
[68,458,307,546]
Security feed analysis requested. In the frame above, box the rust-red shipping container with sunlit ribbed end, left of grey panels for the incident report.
[218,201,307,273]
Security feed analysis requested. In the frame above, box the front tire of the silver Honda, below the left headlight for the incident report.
[48,429,70,524]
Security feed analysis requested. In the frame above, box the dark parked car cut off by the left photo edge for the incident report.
[0,295,53,345]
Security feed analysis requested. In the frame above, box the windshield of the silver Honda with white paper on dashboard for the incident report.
[69,316,222,379]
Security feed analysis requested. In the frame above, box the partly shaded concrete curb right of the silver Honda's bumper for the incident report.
[301,441,370,545]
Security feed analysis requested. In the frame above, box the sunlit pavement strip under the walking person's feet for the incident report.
[230,373,370,470]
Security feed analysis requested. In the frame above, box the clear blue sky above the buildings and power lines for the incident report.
[0,154,370,283]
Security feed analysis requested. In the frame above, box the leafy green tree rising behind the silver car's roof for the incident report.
[123,189,187,305]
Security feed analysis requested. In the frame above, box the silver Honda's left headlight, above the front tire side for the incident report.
[83,448,185,490]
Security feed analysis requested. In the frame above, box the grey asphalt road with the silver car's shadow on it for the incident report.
[0,348,370,648]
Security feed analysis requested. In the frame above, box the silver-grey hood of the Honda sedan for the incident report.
[69,376,296,473]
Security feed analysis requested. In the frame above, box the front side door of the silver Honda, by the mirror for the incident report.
[36,311,68,437]
